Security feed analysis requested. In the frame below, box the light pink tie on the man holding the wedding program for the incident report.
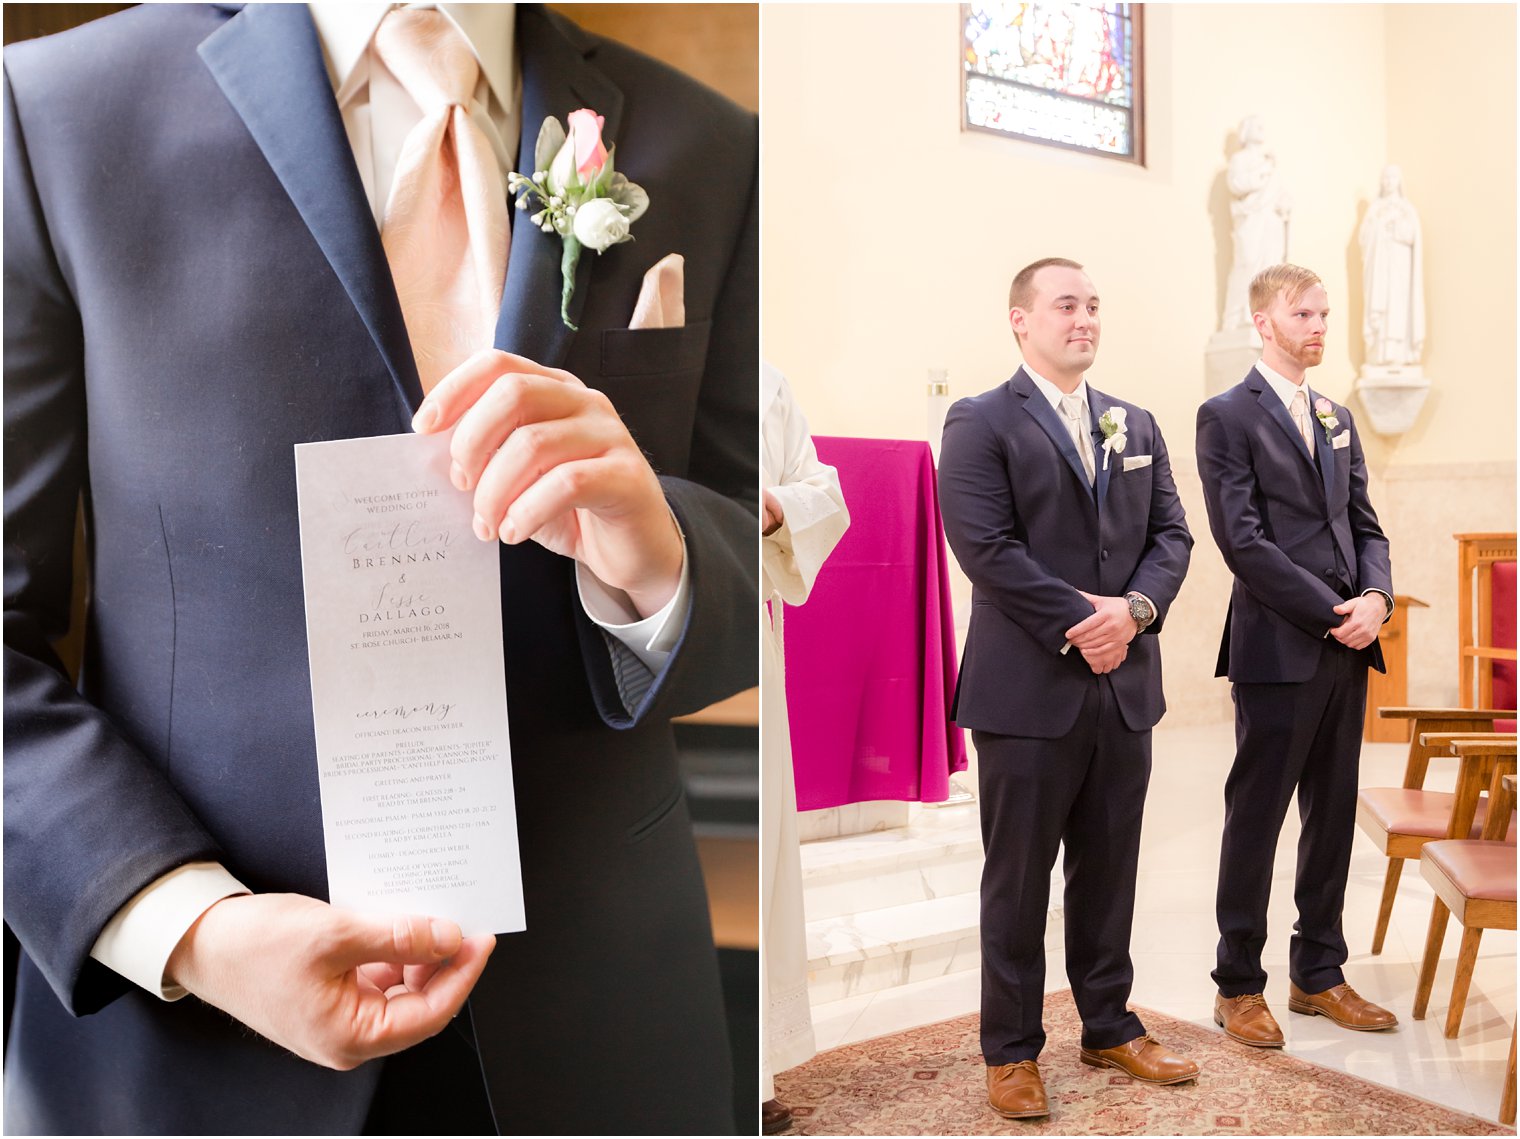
[375,9,511,392]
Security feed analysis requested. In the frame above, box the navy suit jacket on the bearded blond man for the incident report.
[1198,368,1394,684]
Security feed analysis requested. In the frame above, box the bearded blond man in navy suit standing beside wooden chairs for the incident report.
[1198,265,1397,1048]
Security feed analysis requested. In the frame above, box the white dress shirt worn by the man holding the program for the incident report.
[90,0,690,1001]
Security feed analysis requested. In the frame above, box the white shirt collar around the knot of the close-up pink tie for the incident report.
[307,0,517,113]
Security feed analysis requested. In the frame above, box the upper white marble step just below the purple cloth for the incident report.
[801,803,982,922]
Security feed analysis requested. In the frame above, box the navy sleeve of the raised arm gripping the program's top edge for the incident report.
[579,116,760,728]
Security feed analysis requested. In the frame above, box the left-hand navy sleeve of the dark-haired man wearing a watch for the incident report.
[939,400,1093,654]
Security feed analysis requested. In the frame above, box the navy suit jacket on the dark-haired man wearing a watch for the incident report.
[939,368,1193,739]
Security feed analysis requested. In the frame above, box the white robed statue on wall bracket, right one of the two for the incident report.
[1360,166,1424,368]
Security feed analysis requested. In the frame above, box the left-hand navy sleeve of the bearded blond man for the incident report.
[1198,403,1343,637]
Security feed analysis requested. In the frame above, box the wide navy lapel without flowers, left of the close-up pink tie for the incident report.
[199,5,423,415]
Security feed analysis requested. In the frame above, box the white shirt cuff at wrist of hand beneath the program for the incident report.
[90,862,252,1001]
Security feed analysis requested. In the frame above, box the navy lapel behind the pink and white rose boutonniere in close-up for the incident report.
[496,5,623,368]
